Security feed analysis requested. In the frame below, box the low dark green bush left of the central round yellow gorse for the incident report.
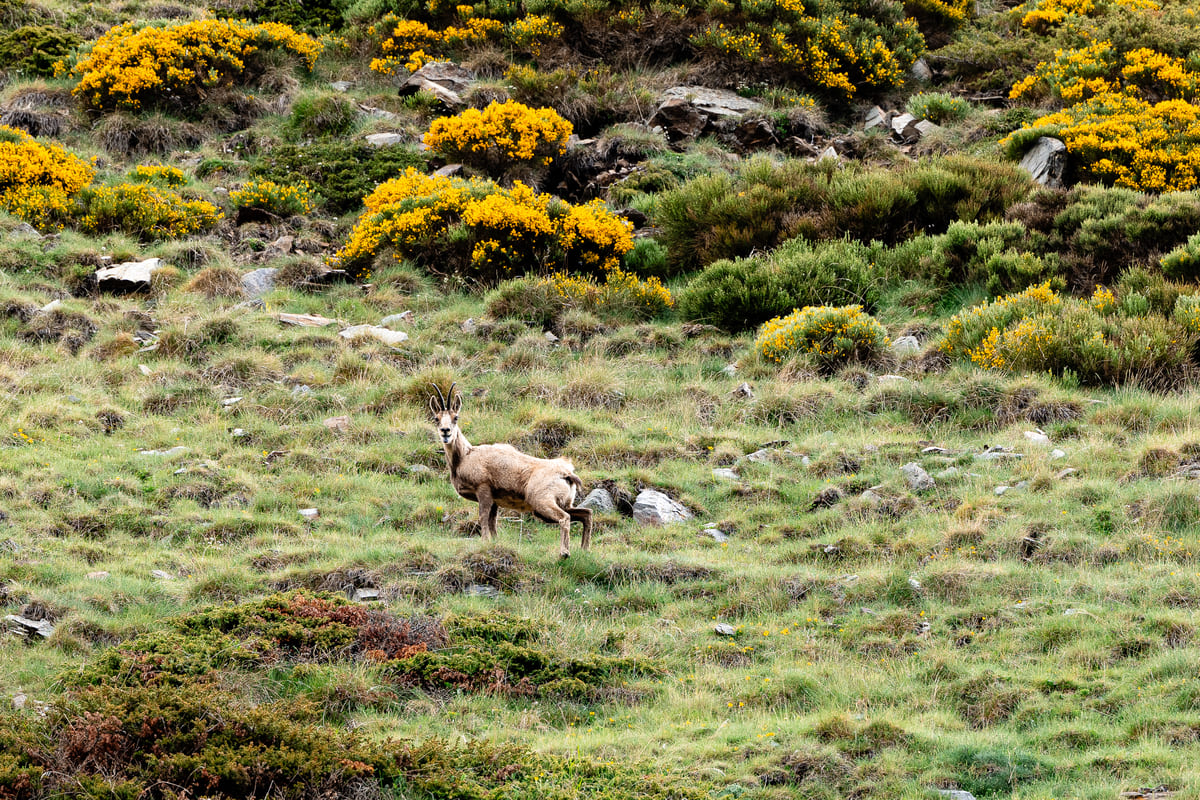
[251,142,425,213]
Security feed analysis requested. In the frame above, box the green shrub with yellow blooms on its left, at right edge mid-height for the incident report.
[941,284,1196,389]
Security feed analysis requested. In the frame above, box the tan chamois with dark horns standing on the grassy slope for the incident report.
[430,384,592,558]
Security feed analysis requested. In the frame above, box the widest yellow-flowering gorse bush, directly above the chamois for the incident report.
[331,168,632,282]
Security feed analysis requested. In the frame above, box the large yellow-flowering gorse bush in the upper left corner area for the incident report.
[70,19,322,112]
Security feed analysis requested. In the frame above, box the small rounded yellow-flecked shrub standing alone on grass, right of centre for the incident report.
[754,306,888,374]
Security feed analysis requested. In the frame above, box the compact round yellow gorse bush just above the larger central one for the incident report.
[424,101,572,175]
